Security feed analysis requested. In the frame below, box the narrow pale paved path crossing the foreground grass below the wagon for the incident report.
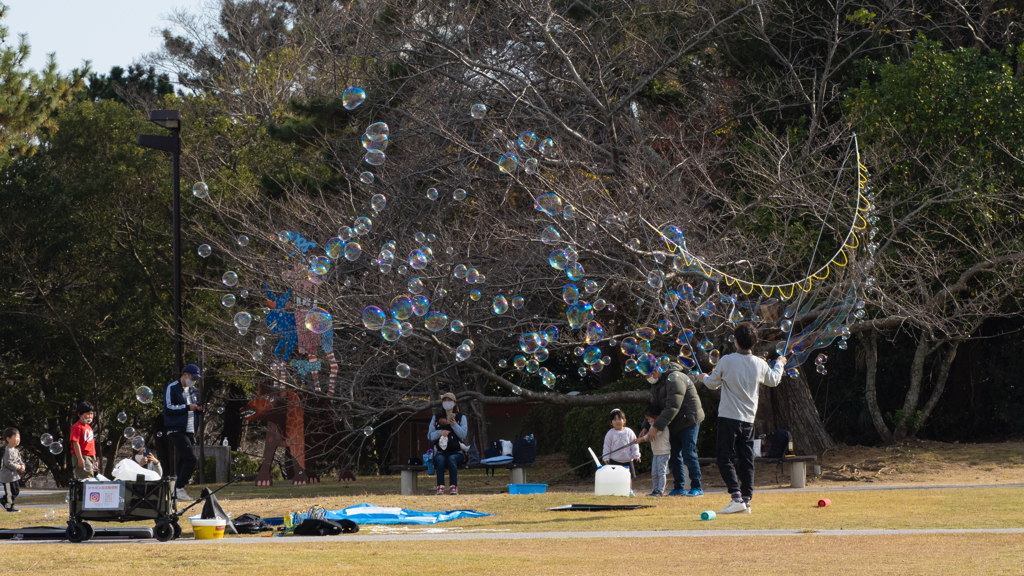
[7,528,1024,546]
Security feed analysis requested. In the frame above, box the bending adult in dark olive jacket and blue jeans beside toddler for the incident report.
[638,363,703,496]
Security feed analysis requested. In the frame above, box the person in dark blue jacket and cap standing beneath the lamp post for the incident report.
[164,364,203,500]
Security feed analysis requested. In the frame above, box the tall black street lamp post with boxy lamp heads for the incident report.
[137,110,184,377]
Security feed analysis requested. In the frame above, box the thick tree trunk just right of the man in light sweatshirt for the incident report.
[756,364,836,455]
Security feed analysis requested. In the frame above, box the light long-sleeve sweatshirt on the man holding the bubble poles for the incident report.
[703,344,785,422]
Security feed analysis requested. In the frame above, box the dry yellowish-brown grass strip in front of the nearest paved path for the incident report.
[4,534,1024,576]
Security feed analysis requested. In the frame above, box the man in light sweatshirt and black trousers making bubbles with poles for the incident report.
[698,322,785,515]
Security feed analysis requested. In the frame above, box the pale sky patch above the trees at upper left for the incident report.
[0,0,208,74]
